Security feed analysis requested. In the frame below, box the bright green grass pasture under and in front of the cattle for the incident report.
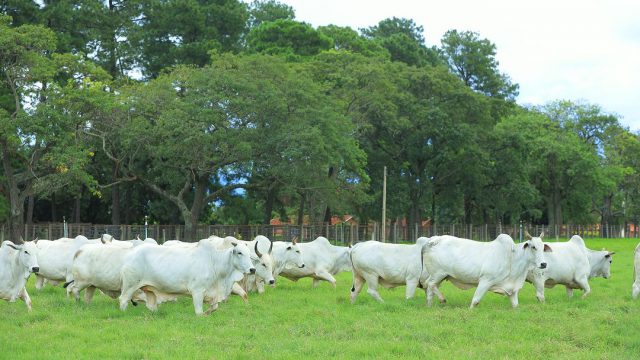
[0,239,640,359]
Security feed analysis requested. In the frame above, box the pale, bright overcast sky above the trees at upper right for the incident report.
[279,0,640,131]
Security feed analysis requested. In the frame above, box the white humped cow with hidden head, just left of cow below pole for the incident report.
[280,236,351,288]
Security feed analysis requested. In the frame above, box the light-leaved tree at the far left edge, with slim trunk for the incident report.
[0,15,99,238]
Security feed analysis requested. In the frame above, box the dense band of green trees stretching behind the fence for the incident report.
[0,0,640,242]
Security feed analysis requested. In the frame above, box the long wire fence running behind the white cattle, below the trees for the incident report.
[0,222,640,245]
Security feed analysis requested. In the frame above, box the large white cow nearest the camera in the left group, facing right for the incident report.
[120,240,256,315]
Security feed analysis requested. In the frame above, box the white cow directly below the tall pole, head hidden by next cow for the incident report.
[348,237,428,303]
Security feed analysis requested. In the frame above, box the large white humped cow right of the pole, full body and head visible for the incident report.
[423,234,551,308]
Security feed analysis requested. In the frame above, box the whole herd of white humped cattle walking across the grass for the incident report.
[0,234,640,315]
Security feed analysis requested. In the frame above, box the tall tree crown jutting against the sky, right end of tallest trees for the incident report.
[441,30,518,101]
